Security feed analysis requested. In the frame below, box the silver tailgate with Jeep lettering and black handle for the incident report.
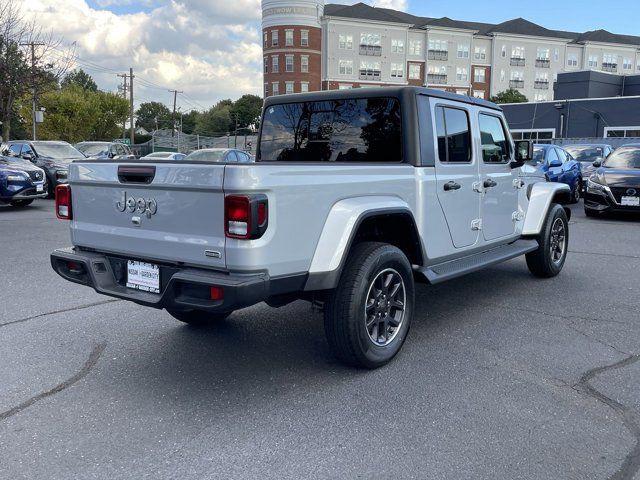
[69,162,226,268]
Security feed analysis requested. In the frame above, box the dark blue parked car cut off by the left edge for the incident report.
[0,156,47,207]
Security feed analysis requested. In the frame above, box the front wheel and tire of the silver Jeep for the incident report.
[526,204,569,278]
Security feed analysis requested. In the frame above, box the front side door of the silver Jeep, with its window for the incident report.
[479,113,519,241]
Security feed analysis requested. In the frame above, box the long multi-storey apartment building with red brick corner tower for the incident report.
[262,0,640,101]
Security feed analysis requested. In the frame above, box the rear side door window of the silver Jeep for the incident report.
[436,107,471,163]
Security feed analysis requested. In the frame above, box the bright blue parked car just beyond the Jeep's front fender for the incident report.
[531,145,582,203]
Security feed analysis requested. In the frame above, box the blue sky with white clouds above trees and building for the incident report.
[20,0,640,111]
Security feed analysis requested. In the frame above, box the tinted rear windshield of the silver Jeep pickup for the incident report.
[256,98,402,163]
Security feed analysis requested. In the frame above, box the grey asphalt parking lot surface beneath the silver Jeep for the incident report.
[0,200,640,480]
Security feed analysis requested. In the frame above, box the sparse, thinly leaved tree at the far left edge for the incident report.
[0,0,74,140]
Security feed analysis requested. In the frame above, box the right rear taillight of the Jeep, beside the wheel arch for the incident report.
[224,194,269,240]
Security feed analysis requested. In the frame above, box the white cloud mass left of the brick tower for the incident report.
[18,0,262,110]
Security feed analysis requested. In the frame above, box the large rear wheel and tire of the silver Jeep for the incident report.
[324,242,414,369]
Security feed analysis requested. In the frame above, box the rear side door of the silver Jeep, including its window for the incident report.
[434,102,482,248]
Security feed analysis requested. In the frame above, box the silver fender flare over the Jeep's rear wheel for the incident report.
[305,196,417,291]
